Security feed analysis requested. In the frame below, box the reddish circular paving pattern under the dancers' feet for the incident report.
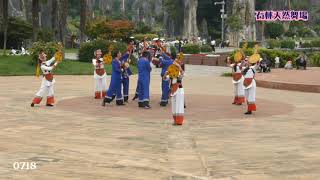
[57,94,294,120]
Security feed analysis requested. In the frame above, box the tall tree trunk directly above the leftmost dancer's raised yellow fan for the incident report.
[59,0,68,45]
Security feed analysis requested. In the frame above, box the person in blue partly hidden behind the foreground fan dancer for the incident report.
[159,51,176,107]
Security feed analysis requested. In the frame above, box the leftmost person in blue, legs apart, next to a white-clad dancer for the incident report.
[102,50,129,106]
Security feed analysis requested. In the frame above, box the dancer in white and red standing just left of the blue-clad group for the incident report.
[92,49,107,99]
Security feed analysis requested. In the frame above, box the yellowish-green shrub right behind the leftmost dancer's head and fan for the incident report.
[29,41,59,65]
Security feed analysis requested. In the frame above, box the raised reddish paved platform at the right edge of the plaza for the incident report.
[256,68,320,93]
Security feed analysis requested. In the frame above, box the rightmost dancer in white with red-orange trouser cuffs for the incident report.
[243,58,257,115]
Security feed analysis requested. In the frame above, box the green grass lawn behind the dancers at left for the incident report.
[0,55,137,76]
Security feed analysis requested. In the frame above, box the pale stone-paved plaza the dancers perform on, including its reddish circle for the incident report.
[0,65,320,180]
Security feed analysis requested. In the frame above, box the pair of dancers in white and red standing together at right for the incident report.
[230,59,257,115]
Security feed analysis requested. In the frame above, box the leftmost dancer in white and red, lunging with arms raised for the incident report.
[31,51,58,107]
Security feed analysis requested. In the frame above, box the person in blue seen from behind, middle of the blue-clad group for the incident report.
[138,51,152,109]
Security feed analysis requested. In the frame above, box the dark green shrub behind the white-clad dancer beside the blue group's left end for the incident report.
[78,39,127,62]
